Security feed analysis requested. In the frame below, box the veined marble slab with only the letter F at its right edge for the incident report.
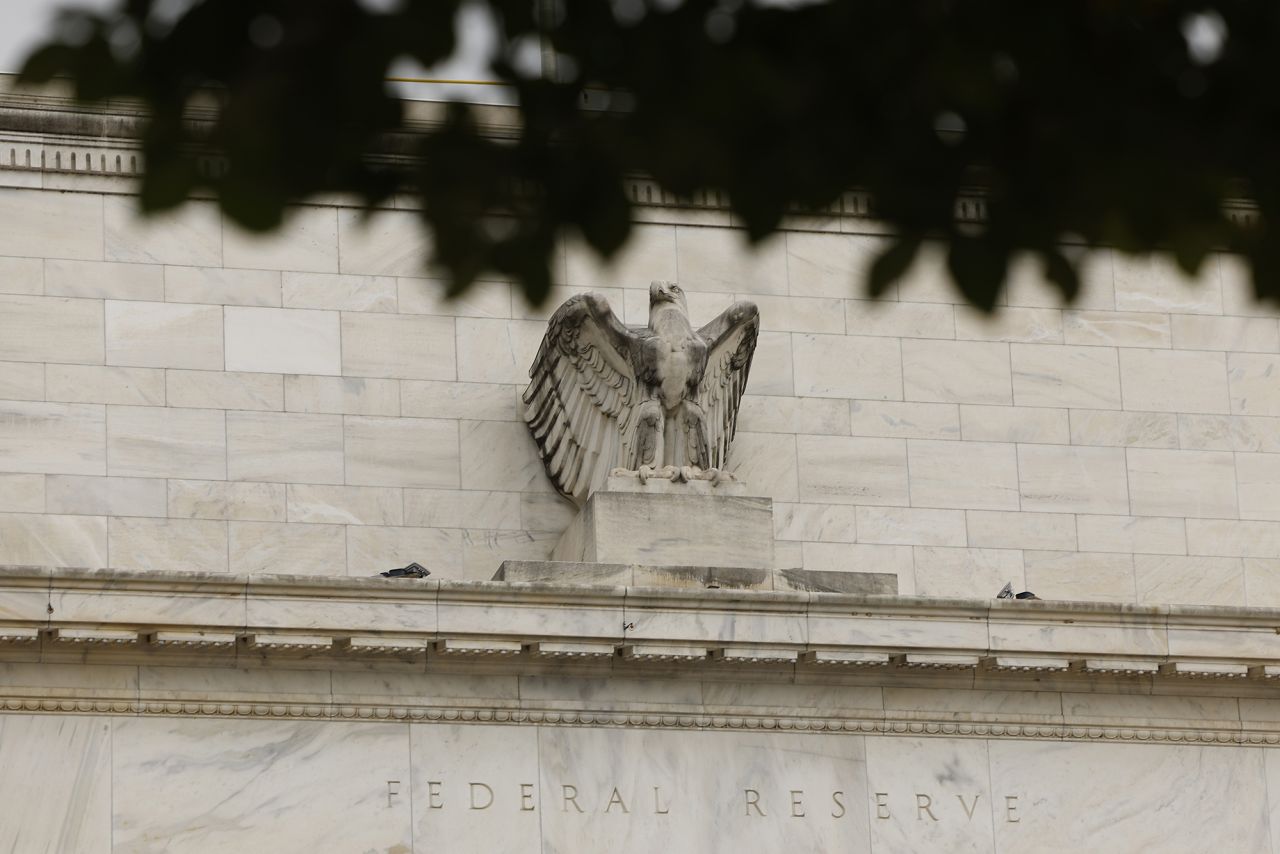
[111,718,412,854]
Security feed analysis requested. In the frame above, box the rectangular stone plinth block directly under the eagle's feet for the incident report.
[552,492,773,568]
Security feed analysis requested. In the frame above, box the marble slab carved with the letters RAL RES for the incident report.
[529,727,870,854]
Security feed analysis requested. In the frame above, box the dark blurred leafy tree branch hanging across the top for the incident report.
[23,0,1280,307]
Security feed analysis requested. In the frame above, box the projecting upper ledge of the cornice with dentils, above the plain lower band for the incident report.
[0,567,1280,685]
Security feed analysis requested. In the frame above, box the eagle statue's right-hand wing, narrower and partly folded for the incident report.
[698,300,760,469]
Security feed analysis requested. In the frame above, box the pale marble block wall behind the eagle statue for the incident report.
[0,184,1280,606]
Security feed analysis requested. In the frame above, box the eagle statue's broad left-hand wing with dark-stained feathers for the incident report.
[524,293,637,503]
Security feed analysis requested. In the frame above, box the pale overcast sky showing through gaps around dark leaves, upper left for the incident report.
[0,0,509,104]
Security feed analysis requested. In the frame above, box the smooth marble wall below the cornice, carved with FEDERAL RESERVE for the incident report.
[0,716,1280,854]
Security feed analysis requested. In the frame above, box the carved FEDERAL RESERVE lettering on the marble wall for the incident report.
[412,780,1023,825]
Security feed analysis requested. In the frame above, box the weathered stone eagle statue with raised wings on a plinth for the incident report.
[524,282,760,503]
